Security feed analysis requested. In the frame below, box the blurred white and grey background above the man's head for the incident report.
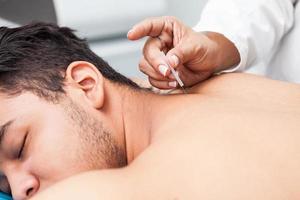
[0,0,207,77]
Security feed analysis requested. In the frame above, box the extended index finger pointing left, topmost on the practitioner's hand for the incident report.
[127,16,176,40]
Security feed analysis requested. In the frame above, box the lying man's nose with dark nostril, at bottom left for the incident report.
[8,174,40,200]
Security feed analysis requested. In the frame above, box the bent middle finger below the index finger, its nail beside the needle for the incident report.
[143,38,170,77]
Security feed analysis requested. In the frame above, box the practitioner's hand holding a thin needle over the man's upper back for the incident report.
[128,16,240,89]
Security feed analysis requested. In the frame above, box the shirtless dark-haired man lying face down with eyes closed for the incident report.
[0,23,300,200]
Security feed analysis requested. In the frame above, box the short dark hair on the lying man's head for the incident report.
[0,22,139,100]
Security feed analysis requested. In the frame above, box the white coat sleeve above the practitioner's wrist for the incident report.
[194,0,298,72]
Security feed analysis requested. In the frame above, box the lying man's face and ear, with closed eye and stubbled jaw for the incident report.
[0,62,131,200]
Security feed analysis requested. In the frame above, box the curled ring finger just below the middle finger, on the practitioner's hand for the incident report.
[139,57,174,81]
